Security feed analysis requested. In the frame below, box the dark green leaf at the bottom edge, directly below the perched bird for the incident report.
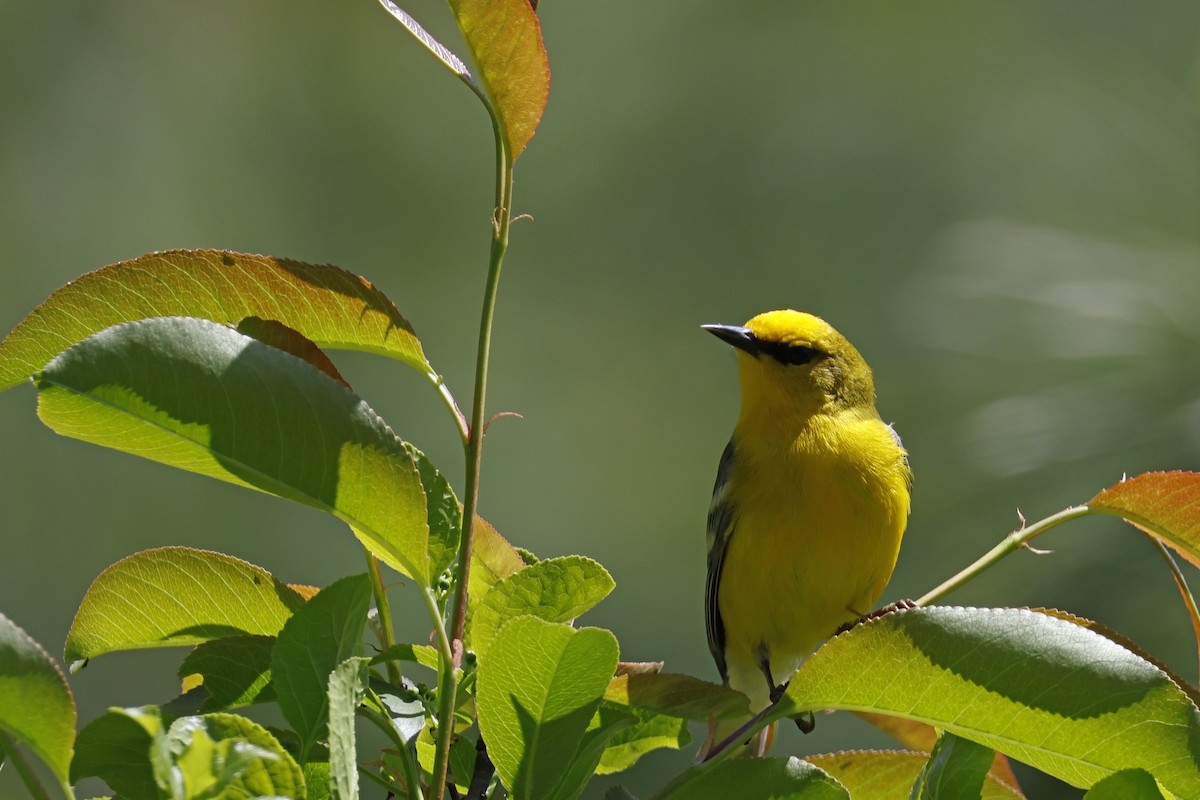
[652,758,858,800]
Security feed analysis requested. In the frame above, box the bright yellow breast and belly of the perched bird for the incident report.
[719,419,908,706]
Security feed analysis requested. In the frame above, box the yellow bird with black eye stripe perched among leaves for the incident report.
[703,311,912,754]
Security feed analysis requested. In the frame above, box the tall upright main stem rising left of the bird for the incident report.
[430,113,512,800]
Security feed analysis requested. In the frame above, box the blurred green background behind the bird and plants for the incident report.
[0,0,1200,798]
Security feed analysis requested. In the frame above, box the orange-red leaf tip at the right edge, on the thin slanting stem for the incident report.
[1087,471,1200,566]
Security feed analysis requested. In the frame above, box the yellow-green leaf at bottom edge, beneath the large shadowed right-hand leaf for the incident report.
[804,750,1025,800]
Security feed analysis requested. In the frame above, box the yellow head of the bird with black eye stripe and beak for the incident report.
[702,309,875,416]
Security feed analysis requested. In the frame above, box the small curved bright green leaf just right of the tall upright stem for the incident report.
[467,555,616,657]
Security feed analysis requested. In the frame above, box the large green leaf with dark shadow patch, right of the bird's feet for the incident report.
[775,607,1200,796]
